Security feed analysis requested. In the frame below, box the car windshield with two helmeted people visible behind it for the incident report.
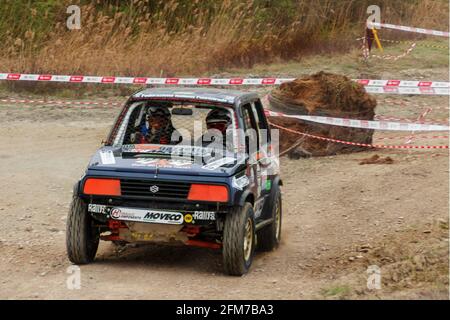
[113,100,238,159]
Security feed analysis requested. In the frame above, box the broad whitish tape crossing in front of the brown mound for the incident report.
[265,110,449,131]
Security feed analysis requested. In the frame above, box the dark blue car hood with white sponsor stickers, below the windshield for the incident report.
[88,146,245,176]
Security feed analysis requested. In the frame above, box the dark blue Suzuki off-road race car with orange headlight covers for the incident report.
[66,88,282,275]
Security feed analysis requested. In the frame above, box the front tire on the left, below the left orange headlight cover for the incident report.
[66,196,100,264]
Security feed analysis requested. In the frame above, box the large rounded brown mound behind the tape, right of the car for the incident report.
[269,72,376,157]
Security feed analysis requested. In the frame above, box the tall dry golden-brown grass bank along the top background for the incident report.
[0,0,448,76]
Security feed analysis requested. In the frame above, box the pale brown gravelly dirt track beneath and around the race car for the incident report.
[0,93,449,299]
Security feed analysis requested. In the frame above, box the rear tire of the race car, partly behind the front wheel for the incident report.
[257,188,282,251]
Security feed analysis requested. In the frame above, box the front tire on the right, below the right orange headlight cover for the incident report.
[222,202,256,276]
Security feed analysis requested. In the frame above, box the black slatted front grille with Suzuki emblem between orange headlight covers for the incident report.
[120,179,191,199]
